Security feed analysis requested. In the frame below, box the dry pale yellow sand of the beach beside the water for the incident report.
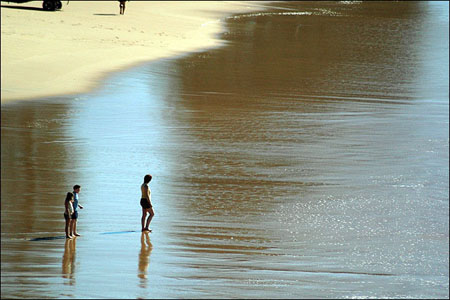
[1,1,267,104]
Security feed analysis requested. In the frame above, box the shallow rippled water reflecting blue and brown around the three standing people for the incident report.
[1,1,449,298]
